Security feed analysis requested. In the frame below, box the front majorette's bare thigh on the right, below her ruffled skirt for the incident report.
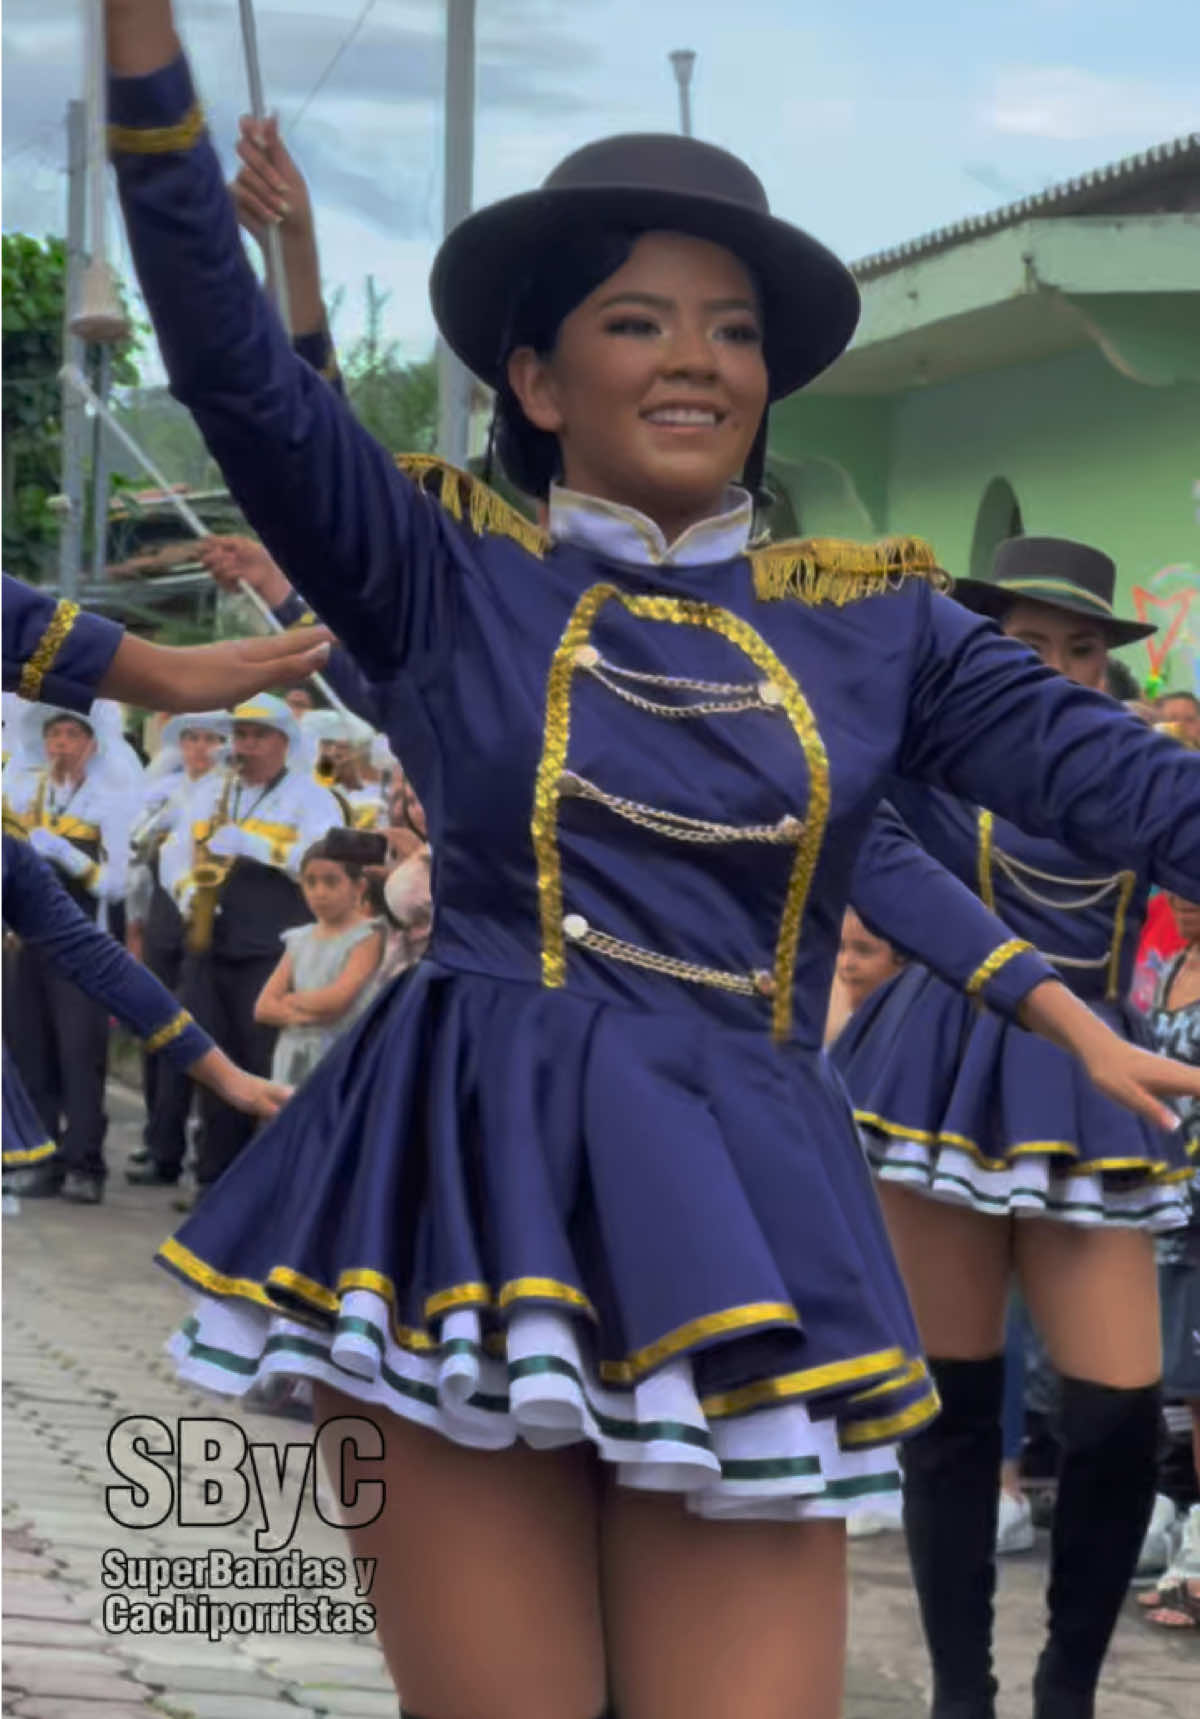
[602,1485,846,1719]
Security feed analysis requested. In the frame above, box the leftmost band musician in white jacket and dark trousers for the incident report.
[5,703,136,1203]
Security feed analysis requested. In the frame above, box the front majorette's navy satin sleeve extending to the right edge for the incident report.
[897,593,1200,899]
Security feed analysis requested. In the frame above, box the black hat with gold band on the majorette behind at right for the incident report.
[954,538,1157,645]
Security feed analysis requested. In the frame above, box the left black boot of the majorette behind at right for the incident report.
[901,1355,1004,1719]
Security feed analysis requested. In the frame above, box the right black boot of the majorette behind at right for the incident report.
[1033,1379,1160,1719]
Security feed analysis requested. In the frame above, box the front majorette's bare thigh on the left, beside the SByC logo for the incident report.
[313,1384,607,1719]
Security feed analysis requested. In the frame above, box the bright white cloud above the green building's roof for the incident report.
[983,65,1200,143]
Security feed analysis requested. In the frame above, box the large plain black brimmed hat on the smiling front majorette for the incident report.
[430,132,860,401]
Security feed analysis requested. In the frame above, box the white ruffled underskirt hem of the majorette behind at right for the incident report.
[865,1131,1190,1234]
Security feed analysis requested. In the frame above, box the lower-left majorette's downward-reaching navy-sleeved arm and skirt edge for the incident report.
[3,817,287,1196]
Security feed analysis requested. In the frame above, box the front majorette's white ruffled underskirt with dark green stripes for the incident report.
[167,1289,899,1521]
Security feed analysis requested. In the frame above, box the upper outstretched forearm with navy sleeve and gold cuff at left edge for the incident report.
[3,572,328,710]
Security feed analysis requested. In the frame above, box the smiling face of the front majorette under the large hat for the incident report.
[509,232,767,541]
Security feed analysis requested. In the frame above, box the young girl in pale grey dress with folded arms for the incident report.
[254,830,383,1086]
